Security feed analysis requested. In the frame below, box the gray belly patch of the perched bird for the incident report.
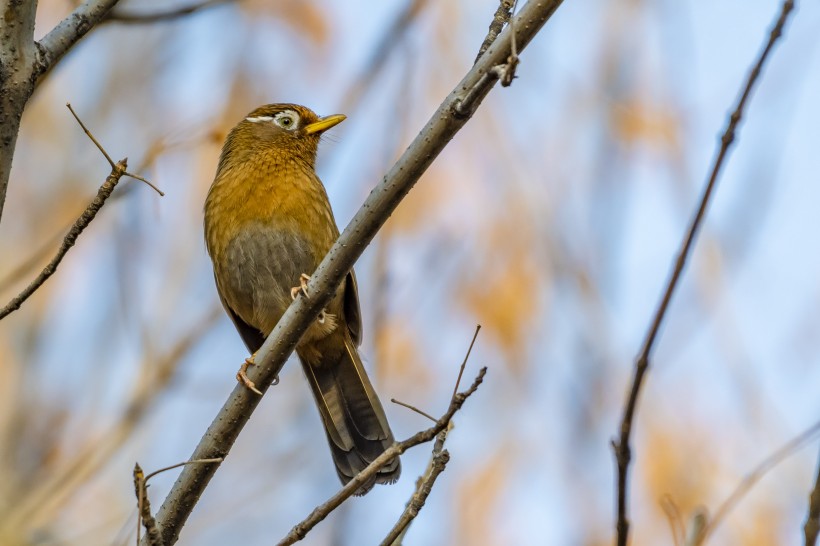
[216,223,321,335]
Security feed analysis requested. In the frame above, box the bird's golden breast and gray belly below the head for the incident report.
[205,153,338,333]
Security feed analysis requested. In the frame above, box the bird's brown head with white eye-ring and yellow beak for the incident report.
[220,104,345,169]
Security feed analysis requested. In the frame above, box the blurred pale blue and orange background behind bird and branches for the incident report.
[0,0,820,545]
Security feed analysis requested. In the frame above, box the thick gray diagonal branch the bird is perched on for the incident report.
[146,0,562,546]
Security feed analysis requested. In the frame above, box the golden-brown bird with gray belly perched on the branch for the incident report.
[204,104,401,495]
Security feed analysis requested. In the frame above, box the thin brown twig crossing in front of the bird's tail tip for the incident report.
[278,368,487,546]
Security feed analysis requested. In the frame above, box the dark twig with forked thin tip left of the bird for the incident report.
[0,104,163,320]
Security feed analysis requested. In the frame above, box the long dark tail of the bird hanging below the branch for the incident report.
[299,328,401,495]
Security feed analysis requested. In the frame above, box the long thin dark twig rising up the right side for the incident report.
[612,0,794,546]
